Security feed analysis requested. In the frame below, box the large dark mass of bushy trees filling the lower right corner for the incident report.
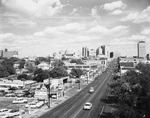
[109,63,150,118]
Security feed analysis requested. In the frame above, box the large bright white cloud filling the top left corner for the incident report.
[1,0,63,17]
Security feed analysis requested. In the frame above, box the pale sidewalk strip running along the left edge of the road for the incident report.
[22,83,87,118]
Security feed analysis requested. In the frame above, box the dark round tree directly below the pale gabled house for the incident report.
[33,68,49,82]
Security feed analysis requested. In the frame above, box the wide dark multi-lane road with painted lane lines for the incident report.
[40,61,112,118]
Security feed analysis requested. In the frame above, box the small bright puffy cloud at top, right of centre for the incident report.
[101,1,127,11]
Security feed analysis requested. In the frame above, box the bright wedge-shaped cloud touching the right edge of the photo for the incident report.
[121,6,150,24]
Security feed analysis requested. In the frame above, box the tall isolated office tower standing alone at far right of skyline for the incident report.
[137,41,146,58]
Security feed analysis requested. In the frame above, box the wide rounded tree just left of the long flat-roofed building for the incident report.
[50,66,68,78]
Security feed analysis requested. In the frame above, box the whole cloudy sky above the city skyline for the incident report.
[0,0,150,57]
